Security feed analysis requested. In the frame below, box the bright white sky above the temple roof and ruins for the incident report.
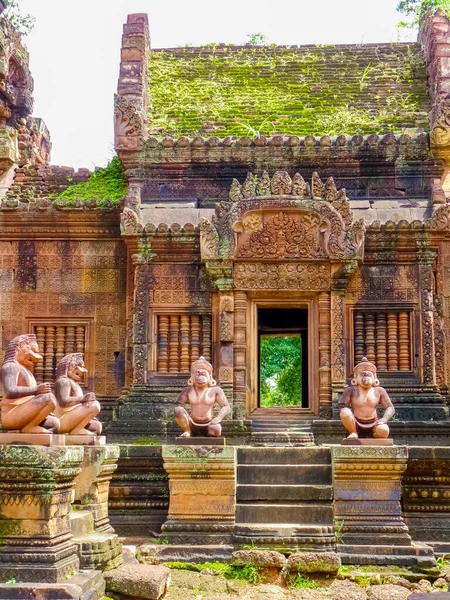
[19,0,415,169]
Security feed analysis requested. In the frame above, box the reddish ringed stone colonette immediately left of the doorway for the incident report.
[233,291,247,419]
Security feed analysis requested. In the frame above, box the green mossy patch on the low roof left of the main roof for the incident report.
[53,156,128,207]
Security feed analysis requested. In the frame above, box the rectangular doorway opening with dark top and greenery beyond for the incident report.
[258,308,309,408]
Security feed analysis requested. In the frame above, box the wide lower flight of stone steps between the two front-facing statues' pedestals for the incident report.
[234,446,336,552]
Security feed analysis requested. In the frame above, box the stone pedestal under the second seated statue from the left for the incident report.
[68,446,122,570]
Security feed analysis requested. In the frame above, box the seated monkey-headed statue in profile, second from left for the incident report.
[55,352,102,435]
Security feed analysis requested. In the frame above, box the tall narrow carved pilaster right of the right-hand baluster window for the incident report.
[419,251,436,385]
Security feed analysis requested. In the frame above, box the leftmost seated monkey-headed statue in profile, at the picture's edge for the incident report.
[0,334,60,433]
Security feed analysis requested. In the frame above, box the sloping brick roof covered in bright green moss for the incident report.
[149,43,430,137]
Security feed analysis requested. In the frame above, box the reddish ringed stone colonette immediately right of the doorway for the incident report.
[319,292,331,412]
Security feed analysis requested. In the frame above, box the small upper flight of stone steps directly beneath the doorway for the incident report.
[250,406,317,446]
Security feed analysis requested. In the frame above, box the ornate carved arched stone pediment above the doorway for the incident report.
[200,171,365,261]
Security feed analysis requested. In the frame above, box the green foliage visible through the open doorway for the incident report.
[260,335,302,406]
